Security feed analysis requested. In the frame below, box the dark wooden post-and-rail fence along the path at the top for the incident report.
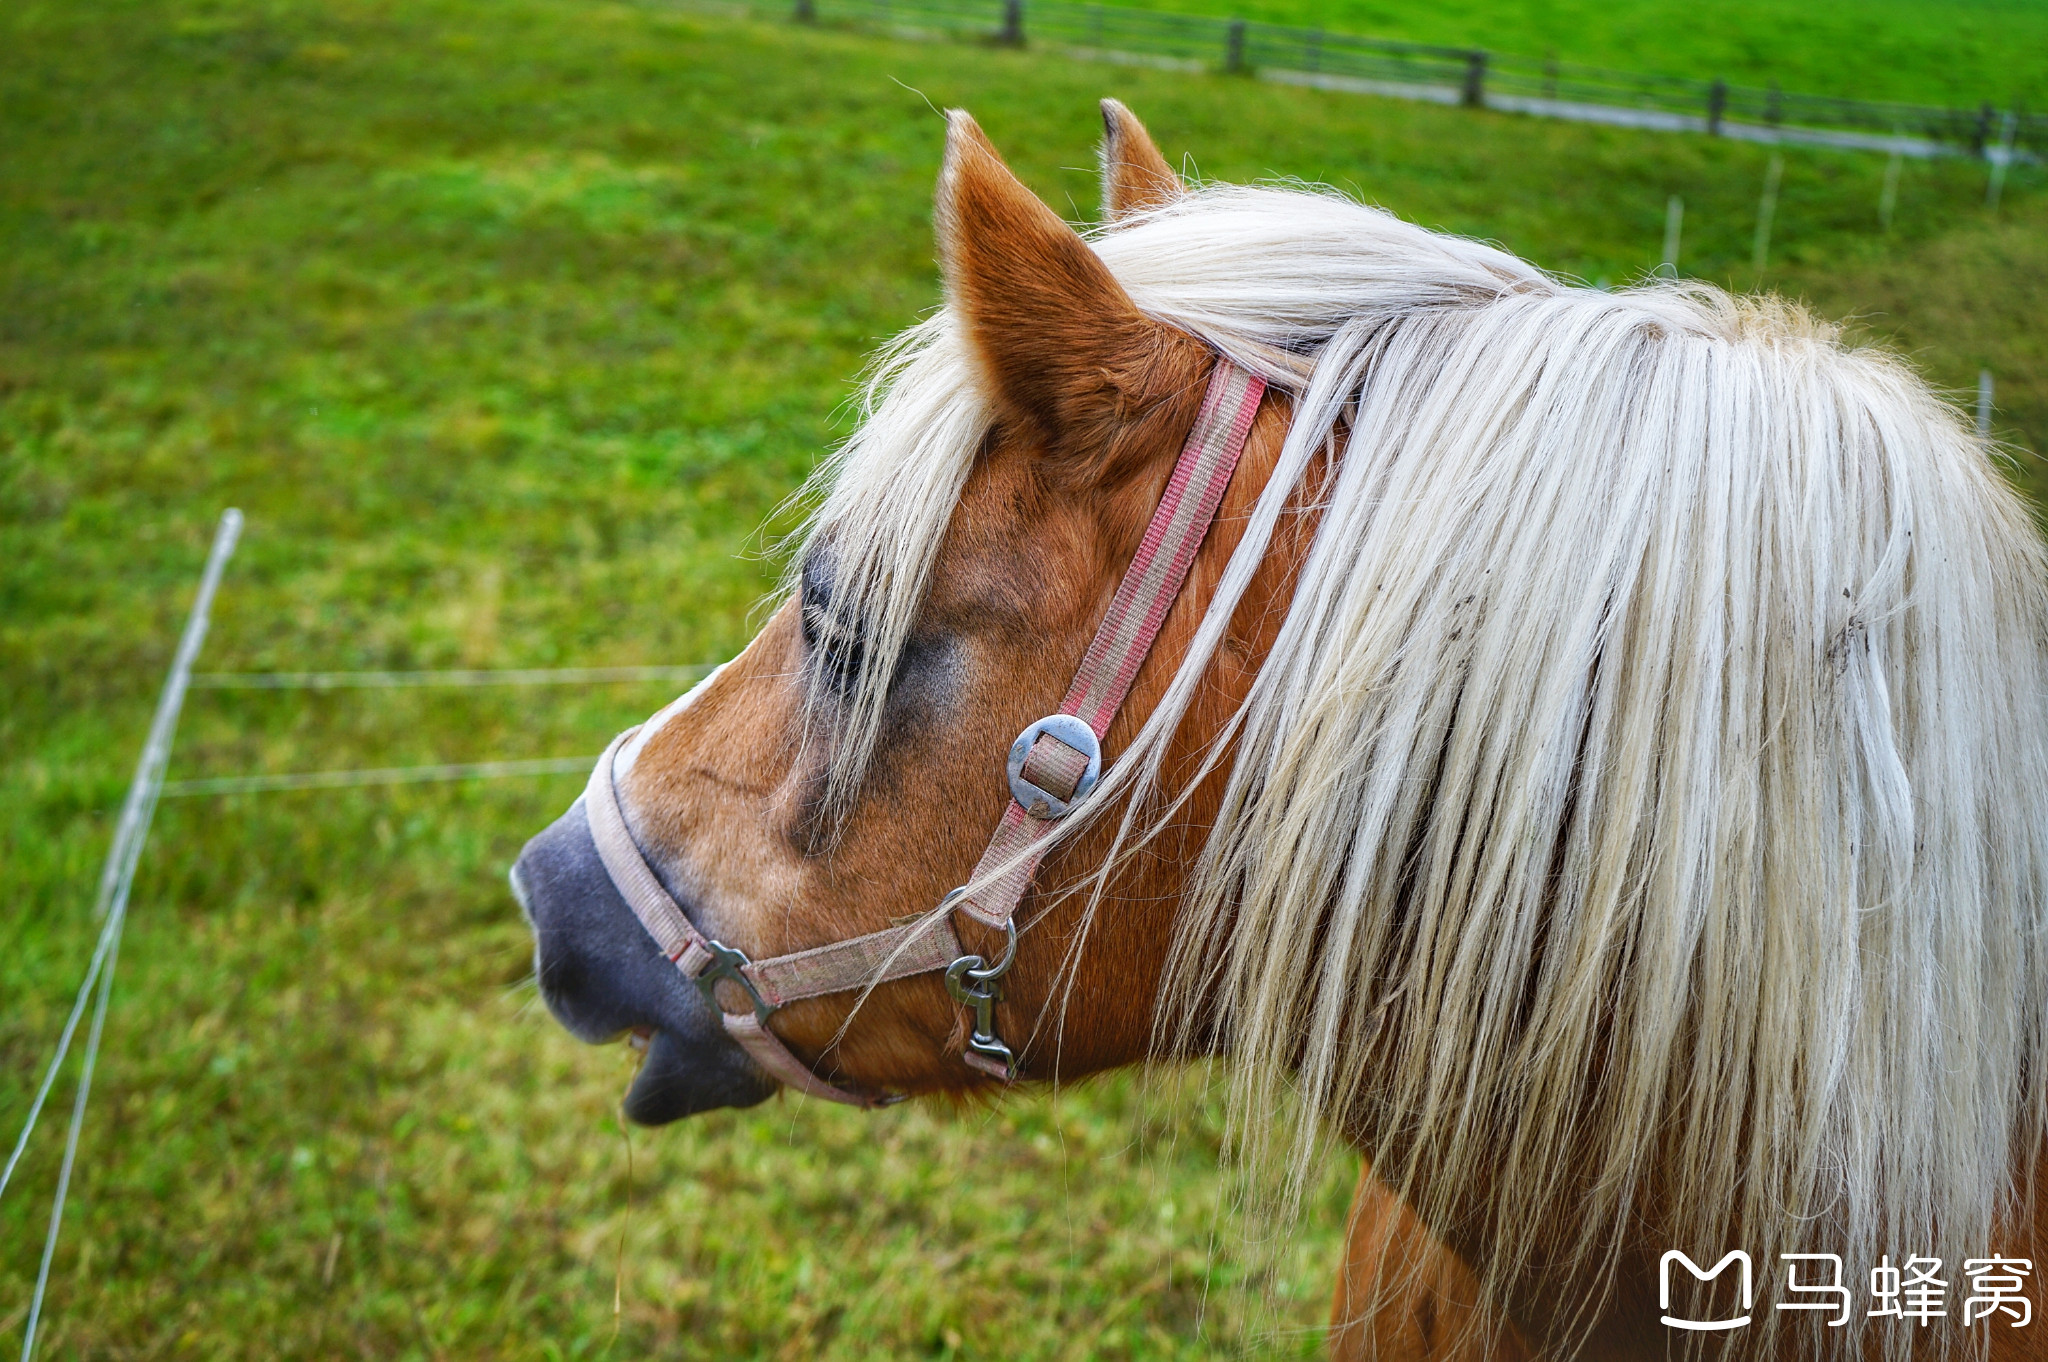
[765,0,2048,160]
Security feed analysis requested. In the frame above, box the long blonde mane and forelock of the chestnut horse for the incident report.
[786,186,2048,1352]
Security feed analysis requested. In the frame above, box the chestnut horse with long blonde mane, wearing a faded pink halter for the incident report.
[512,100,2048,1360]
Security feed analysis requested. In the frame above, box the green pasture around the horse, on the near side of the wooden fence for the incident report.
[0,0,2048,1358]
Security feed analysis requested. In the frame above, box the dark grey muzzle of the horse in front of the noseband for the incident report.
[512,799,776,1126]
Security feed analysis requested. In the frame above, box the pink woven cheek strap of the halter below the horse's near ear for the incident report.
[954,360,1266,928]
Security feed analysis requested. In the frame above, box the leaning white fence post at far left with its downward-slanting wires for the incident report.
[0,508,242,1362]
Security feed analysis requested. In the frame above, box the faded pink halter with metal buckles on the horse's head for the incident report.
[584,358,1266,1106]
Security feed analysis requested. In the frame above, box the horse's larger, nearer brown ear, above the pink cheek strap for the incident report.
[936,111,1200,453]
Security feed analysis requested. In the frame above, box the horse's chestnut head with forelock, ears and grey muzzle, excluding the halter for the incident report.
[512,100,1286,1122]
